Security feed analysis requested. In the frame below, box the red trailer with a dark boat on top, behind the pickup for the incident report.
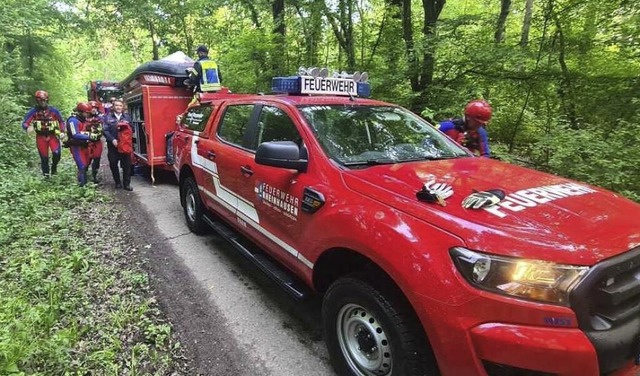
[121,52,194,180]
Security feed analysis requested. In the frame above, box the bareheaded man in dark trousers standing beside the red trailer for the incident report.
[104,100,133,191]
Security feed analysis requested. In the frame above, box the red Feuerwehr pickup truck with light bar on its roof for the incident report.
[171,76,640,376]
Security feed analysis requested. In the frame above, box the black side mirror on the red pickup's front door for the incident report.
[256,141,309,172]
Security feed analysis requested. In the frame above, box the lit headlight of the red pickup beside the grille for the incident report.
[451,247,589,306]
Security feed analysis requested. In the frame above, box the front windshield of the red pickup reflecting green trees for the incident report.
[298,105,469,166]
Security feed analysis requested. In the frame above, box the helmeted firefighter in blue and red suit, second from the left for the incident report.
[66,102,101,187]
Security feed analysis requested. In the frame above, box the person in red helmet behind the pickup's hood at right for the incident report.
[437,100,493,157]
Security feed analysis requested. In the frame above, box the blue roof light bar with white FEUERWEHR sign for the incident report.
[271,76,371,98]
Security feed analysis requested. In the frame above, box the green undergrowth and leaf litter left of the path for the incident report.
[0,99,189,375]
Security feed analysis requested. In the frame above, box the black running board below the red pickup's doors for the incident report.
[202,214,311,300]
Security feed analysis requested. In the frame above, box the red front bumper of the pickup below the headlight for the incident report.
[414,274,640,376]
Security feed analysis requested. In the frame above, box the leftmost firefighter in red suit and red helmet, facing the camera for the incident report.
[22,90,64,178]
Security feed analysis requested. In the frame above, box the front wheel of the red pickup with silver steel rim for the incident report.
[322,277,439,376]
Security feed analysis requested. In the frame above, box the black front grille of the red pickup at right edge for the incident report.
[570,247,640,373]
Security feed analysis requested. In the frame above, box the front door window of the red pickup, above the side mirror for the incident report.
[251,106,301,150]
